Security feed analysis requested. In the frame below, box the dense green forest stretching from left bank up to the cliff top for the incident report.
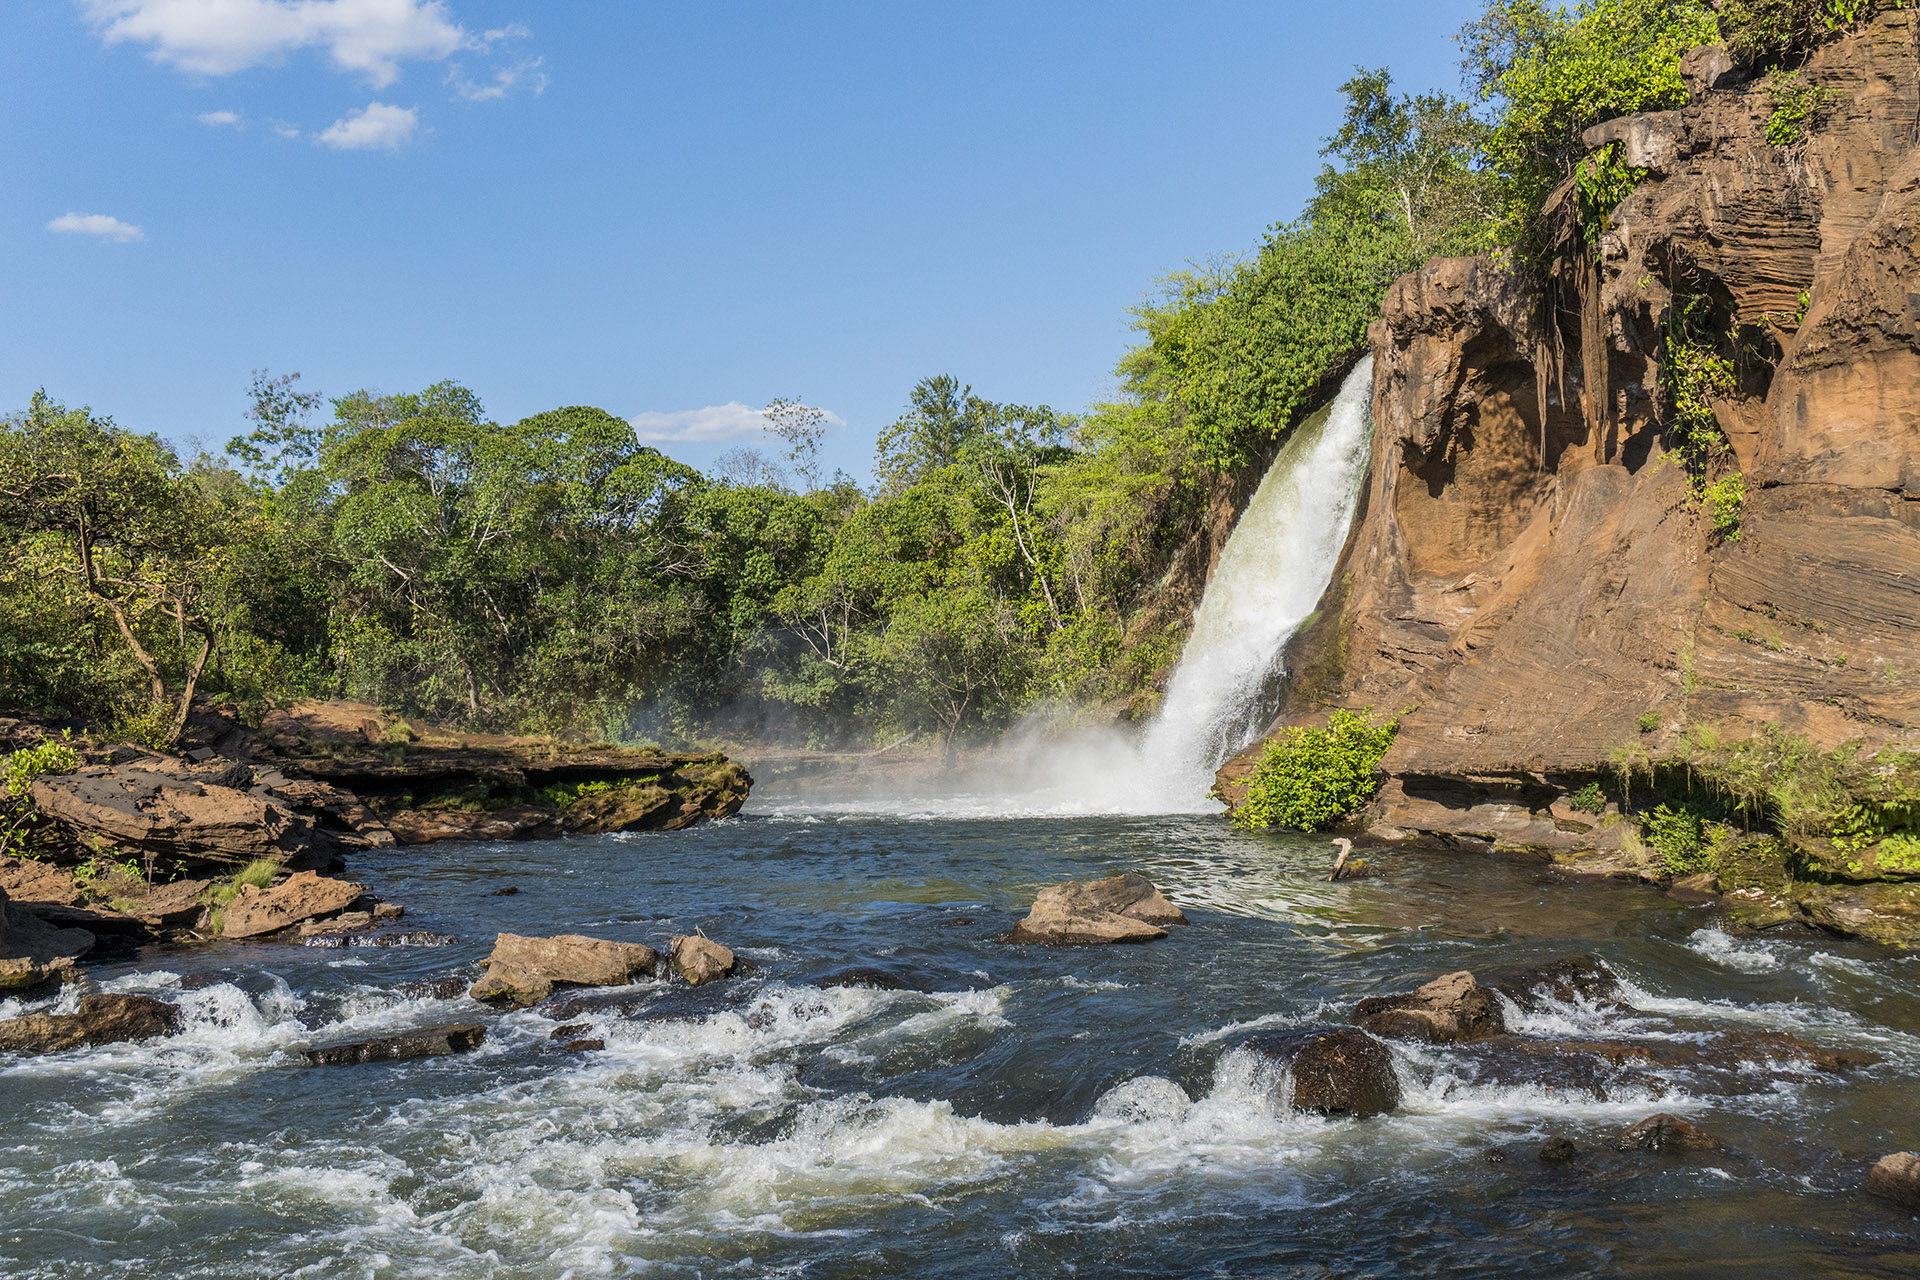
[0,0,1872,747]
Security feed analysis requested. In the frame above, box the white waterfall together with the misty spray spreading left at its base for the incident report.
[776,357,1373,818]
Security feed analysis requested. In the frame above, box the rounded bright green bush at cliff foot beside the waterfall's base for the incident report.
[1233,706,1400,831]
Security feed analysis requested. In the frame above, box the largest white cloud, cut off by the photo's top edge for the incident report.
[79,0,474,88]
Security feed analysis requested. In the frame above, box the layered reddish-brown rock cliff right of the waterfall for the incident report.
[1221,22,1920,871]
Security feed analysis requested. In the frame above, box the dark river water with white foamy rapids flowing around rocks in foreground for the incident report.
[0,796,1920,1280]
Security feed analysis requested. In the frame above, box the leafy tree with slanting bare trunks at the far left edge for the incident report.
[0,391,227,745]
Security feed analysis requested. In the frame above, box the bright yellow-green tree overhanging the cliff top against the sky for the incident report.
[1461,0,1718,248]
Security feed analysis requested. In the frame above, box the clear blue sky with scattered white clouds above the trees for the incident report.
[0,0,1476,478]
